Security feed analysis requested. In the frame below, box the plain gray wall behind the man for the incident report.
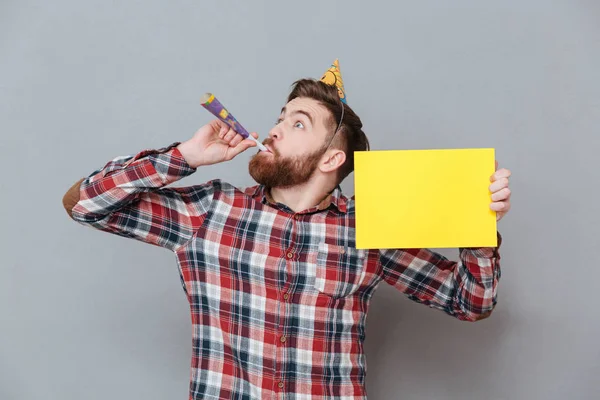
[0,0,600,400]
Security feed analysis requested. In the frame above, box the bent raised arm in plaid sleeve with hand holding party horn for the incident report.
[63,120,256,251]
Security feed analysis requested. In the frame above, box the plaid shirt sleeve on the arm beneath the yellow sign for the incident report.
[379,233,502,321]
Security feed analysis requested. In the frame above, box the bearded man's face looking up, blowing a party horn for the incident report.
[249,97,331,187]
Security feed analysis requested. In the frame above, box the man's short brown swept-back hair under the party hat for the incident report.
[287,79,370,184]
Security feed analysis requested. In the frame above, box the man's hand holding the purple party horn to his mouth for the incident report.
[177,119,258,168]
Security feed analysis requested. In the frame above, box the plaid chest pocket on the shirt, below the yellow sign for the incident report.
[314,242,366,298]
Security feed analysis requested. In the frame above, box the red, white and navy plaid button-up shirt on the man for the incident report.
[72,143,500,400]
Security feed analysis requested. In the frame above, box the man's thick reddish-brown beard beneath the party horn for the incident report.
[248,139,326,188]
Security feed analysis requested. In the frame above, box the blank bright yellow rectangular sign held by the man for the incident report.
[354,149,497,249]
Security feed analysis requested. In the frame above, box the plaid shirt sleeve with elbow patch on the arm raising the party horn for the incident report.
[72,143,214,251]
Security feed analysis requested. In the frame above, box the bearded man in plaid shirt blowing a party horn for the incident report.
[64,64,510,399]
